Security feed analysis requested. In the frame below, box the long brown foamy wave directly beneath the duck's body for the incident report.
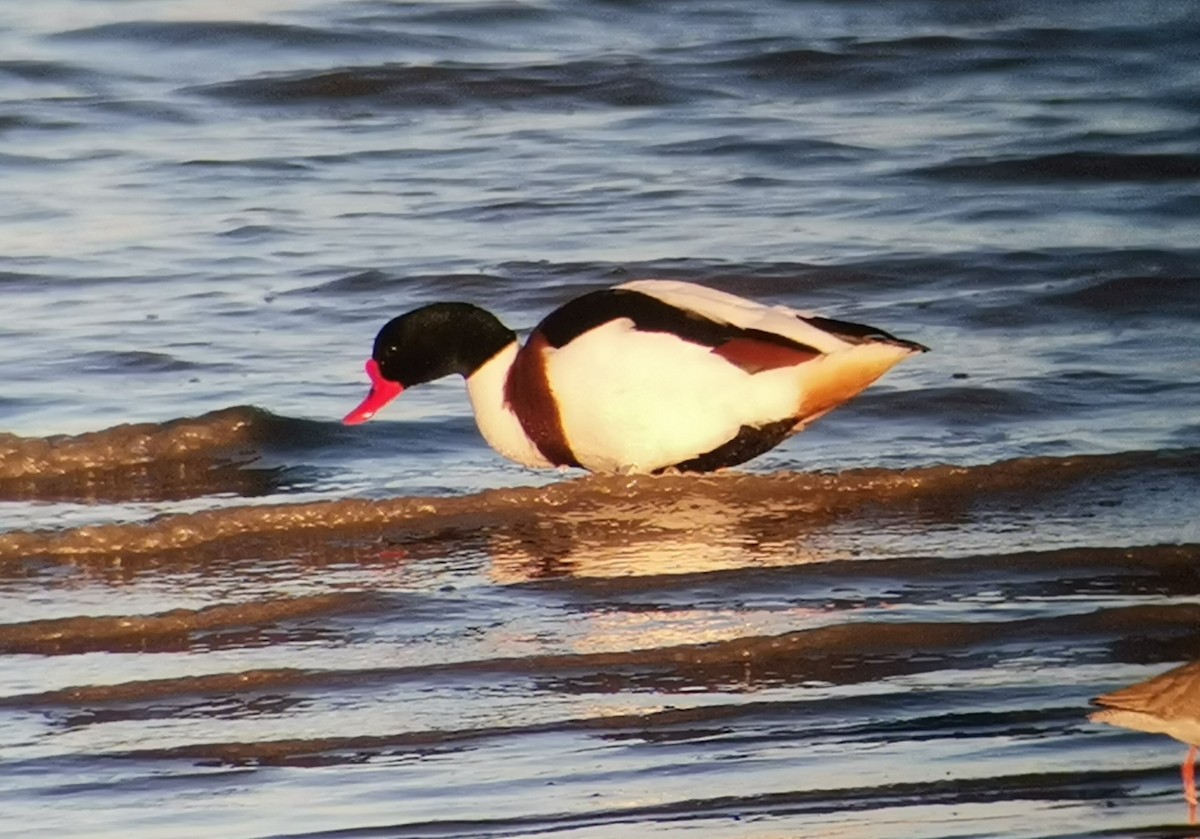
[0,446,1200,563]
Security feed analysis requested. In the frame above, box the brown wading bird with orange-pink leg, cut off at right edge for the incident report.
[1087,660,1200,825]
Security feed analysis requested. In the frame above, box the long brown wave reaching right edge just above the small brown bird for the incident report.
[11,604,1200,707]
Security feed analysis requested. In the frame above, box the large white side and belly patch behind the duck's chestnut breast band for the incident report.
[546,320,799,472]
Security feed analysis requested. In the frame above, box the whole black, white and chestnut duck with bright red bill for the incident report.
[343,280,928,474]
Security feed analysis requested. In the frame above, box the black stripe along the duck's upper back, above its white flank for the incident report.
[538,288,820,354]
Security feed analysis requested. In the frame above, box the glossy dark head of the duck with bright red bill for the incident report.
[342,302,516,425]
